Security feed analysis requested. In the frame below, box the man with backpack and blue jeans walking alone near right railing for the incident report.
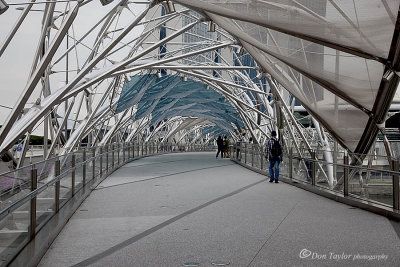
[264,131,283,183]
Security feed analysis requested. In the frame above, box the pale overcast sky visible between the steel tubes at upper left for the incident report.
[0,0,145,136]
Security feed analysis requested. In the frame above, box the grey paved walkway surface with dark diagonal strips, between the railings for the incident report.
[39,153,400,267]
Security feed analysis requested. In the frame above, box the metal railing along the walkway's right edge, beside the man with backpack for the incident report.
[230,143,400,211]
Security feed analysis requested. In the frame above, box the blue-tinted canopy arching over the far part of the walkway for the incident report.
[117,74,244,130]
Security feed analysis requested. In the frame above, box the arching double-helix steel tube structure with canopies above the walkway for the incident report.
[0,0,400,266]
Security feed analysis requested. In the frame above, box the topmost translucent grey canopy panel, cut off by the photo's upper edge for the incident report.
[176,0,400,58]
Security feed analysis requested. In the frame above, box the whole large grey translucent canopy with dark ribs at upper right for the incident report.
[176,0,400,153]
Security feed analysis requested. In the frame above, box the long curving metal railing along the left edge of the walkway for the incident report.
[0,143,215,265]
